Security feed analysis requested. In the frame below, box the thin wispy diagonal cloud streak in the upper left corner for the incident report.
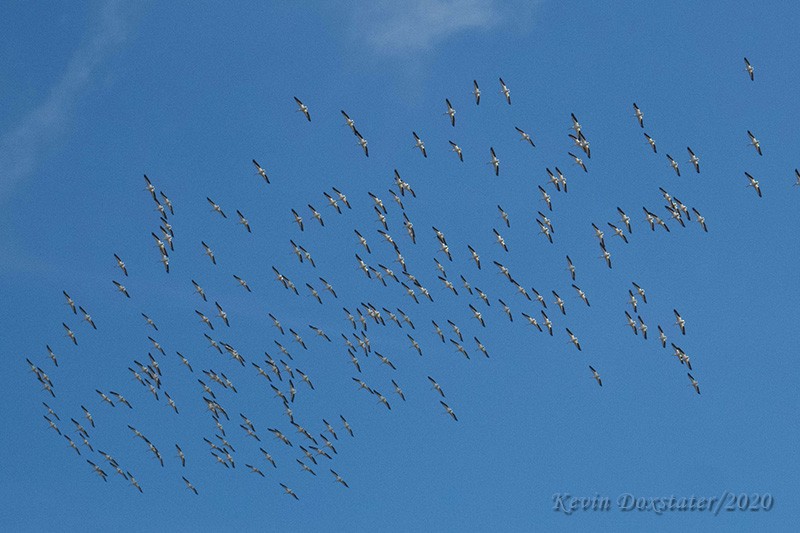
[0,1,133,205]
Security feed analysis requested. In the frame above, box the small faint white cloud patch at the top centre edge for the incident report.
[355,0,503,56]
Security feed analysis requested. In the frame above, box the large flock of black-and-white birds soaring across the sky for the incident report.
[26,58,800,499]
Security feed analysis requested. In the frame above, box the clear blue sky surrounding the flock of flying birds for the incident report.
[0,0,800,531]
